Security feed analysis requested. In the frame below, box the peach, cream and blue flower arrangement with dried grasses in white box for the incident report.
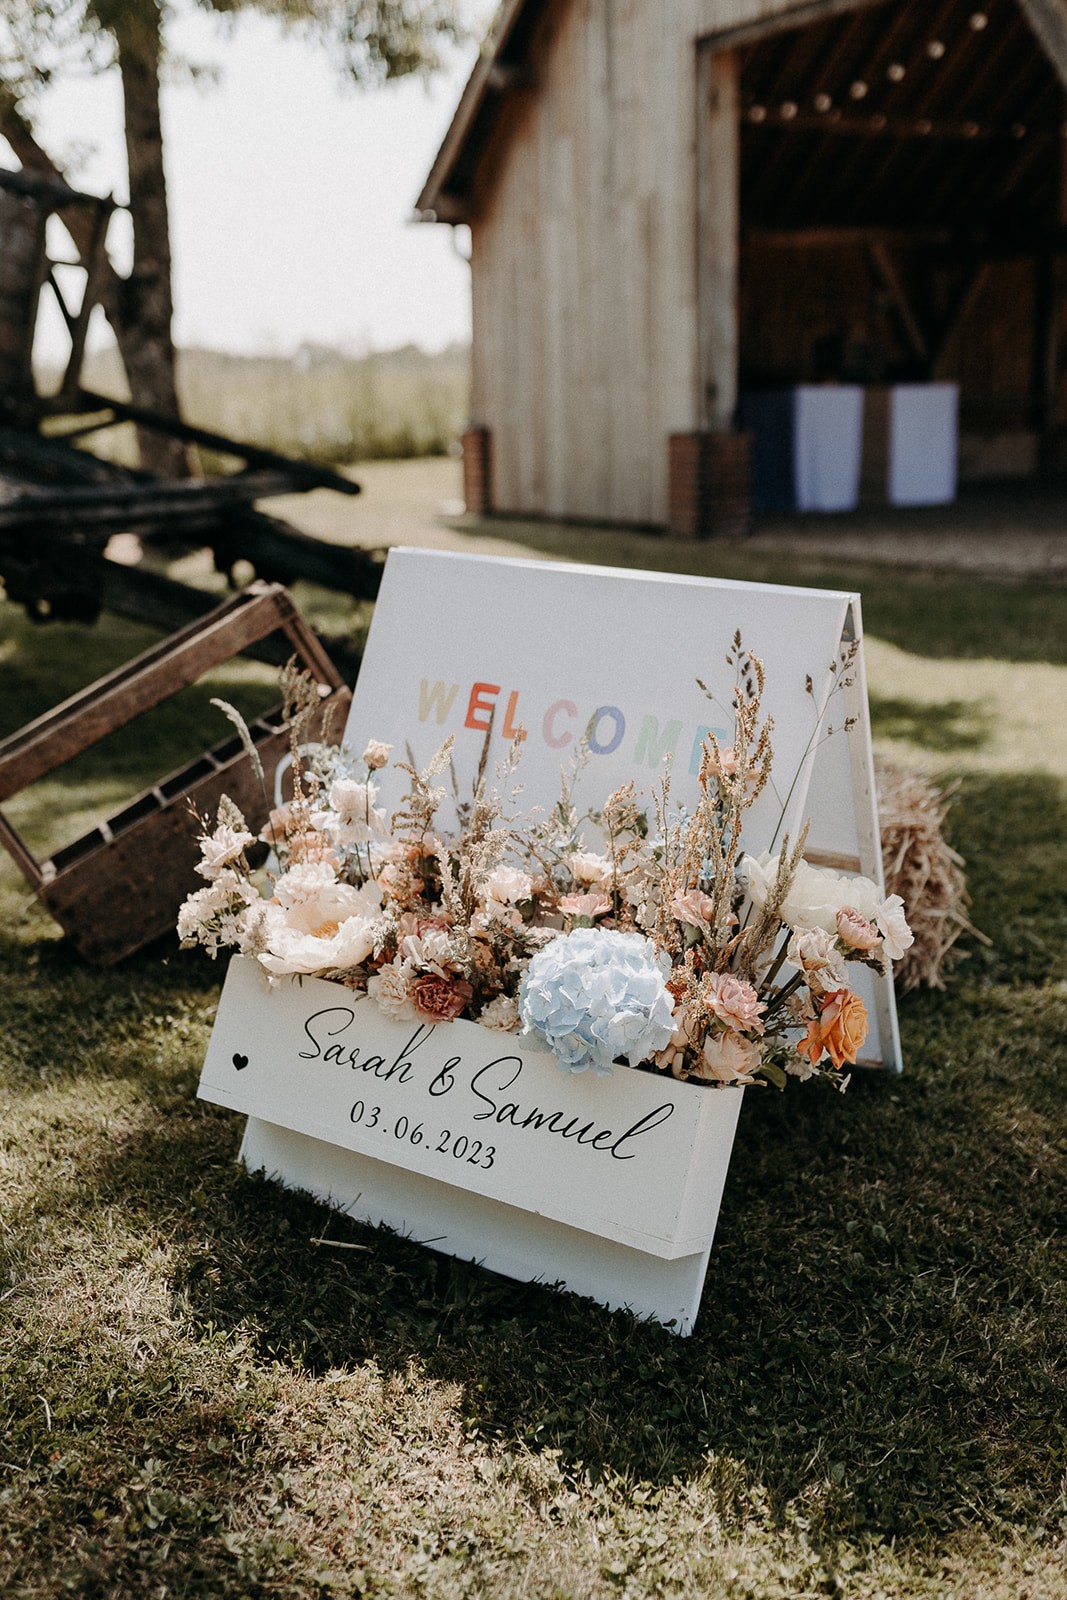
[178,635,912,1088]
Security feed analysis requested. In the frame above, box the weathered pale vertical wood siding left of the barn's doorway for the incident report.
[472,0,811,523]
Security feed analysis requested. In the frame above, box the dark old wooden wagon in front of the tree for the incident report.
[0,170,381,646]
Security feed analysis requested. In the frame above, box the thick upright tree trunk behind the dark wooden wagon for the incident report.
[115,6,190,478]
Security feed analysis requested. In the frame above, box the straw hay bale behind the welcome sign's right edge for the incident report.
[875,757,990,989]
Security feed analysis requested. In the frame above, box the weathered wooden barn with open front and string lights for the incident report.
[418,0,1067,536]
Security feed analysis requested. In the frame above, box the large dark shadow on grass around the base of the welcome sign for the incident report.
[5,779,1067,1544]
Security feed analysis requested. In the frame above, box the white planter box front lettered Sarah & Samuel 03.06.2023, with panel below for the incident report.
[200,957,742,1333]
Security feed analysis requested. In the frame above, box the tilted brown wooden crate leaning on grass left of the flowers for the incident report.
[0,584,352,966]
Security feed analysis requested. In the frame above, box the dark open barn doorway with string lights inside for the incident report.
[733,0,1067,505]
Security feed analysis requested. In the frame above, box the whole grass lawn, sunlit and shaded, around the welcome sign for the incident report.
[0,469,1067,1600]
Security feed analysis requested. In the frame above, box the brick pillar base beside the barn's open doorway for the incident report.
[667,432,752,539]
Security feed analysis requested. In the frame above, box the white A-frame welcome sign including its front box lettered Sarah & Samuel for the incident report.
[200,550,901,1333]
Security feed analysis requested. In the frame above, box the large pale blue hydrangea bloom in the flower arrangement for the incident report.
[518,928,673,1074]
